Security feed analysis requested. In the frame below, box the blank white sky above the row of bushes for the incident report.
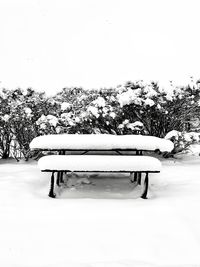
[0,0,200,94]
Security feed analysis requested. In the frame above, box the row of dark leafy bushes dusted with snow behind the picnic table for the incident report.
[0,78,200,158]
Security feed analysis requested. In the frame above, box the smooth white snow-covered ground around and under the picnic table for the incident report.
[0,152,200,267]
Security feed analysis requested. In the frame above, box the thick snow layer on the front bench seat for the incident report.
[38,155,161,171]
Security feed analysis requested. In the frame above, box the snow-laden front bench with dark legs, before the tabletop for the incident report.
[38,155,161,199]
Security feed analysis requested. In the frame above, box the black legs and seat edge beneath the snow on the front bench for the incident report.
[42,169,160,199]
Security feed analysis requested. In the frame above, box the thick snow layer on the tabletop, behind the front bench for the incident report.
[30,134,174,152]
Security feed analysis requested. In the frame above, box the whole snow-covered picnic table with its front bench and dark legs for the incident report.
[30,134,174,198]
